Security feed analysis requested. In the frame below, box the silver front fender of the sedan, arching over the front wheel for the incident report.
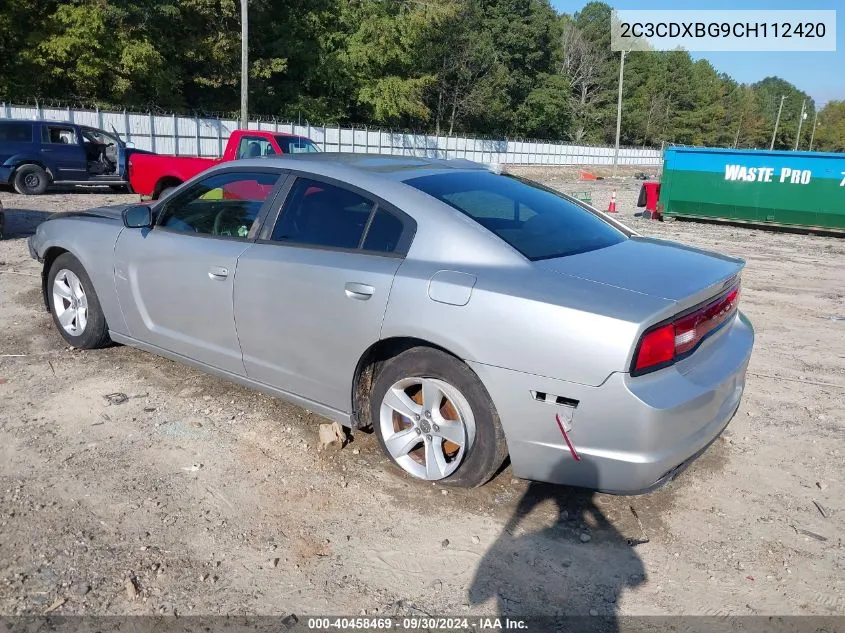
[34,215,128,334]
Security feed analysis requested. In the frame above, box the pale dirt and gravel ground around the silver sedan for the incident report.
[0,175,845,619]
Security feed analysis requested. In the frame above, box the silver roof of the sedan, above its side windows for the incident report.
[251,152,487,182]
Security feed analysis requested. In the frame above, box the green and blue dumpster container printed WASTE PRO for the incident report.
[658,147,845,231]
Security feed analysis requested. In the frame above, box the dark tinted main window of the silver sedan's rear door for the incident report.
[271,178,375,248]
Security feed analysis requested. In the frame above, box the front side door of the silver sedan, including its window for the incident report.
[115,168,281,375]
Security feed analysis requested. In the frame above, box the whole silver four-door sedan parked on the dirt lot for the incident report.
[29,154,754,493]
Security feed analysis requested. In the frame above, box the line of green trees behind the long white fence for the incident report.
[0,0,845,151]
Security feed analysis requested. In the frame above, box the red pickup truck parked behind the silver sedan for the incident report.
[129,130,320,199]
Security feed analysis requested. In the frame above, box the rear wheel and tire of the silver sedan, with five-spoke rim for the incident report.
[370,347,507,488]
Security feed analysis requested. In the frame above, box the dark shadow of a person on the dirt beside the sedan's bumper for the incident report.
[469,459,646,631]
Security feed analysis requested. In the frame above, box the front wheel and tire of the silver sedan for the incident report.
[47,253,111,349]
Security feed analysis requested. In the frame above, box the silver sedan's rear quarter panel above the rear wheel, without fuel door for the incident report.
[382,259,669,386]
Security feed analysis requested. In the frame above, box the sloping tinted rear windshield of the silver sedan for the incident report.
[405,171,626,260]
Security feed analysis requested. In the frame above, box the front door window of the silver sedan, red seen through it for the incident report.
[158,172,279,237]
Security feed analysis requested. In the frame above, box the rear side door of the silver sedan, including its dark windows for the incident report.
[235,176,416,411]
